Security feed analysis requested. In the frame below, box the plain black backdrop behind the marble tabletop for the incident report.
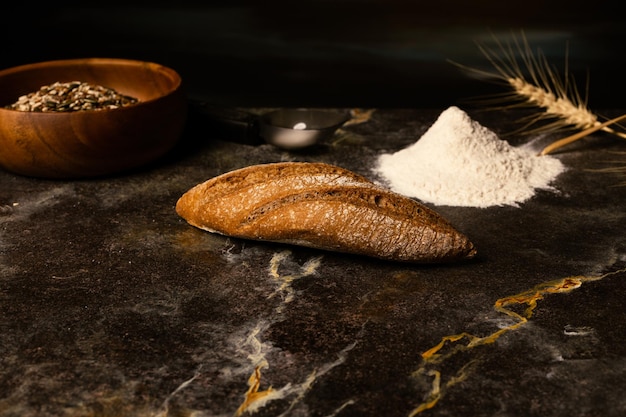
[0,0,626,108]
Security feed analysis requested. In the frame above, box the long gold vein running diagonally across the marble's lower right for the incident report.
[409,268,626,417]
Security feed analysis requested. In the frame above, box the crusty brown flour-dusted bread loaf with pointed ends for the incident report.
[176,162,476,263]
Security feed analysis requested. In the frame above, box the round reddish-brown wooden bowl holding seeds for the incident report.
[0,58,187,179]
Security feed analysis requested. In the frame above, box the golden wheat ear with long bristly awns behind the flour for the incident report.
[453,34,626,155]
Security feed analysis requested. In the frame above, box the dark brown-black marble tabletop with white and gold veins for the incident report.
[0,108,626,417]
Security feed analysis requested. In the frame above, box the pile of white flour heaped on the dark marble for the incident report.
[375,106,565,207]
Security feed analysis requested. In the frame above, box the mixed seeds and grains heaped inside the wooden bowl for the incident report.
[6,81,139,112]
